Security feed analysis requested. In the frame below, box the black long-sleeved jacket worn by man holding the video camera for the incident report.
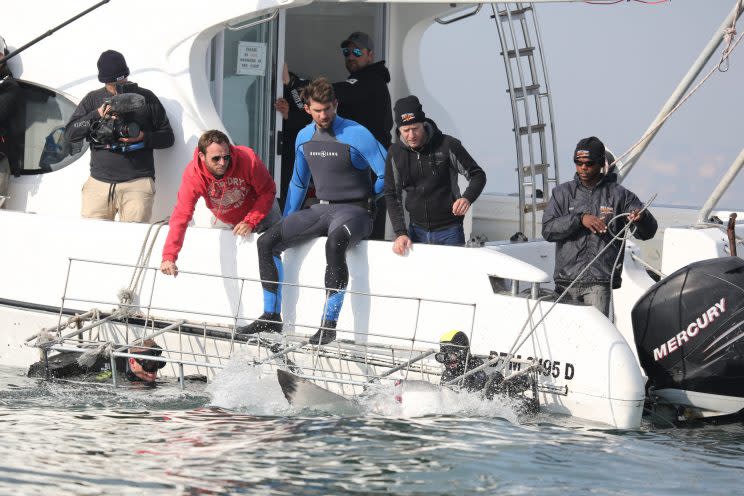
[65,83,174,183]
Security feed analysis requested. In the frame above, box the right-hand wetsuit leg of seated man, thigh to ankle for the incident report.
[323,205,372,322]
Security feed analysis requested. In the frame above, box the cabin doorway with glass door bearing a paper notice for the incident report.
[208,3,387,203]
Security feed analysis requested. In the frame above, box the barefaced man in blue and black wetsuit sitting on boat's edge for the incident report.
[236,78,386,344]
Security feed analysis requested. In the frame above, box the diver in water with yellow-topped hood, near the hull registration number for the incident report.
[434,330,532,401]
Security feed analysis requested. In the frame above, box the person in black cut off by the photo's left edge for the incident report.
[0,37,21,204]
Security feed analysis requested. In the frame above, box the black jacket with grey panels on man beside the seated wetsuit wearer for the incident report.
[384,119,486,236]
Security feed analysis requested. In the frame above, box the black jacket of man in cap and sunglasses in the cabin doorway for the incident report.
[333,60,393,149]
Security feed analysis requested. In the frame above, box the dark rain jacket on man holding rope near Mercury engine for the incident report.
[542,173,657,289]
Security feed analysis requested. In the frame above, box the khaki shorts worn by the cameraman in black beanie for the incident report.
[80,177,155,222]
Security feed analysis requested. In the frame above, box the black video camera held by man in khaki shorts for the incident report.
[88,83,145,151]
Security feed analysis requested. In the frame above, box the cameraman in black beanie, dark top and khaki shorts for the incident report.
[65,50,174,222]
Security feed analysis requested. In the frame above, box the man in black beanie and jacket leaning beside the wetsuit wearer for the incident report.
[385,96,486,255]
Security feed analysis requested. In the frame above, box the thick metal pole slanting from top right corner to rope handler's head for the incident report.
[618,2,742,182]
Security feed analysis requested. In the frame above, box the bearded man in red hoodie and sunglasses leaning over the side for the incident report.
[160,130,281,276]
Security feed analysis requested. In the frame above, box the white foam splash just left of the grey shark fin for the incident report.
[206,354,291,415]
